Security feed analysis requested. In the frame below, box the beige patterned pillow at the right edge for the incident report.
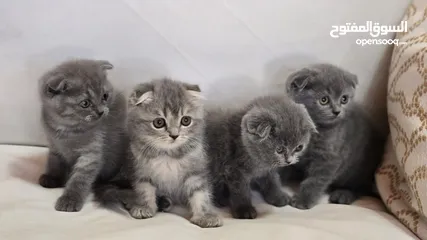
[376,0,427,239]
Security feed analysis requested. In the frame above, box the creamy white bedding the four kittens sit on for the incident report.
[0,145,415,240]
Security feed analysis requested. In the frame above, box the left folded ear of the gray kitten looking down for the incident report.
[242,110,274,141]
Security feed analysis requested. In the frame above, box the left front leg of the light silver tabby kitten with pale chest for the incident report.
[125,178,158,219]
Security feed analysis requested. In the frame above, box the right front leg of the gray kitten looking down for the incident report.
[254,171,291,207]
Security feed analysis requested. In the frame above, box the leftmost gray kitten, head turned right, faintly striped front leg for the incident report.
[39,59,128,212]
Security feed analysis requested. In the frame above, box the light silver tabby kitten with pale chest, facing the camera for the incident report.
[126,79,222,227]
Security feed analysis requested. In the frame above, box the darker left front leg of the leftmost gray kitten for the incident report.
[39,149,68,188]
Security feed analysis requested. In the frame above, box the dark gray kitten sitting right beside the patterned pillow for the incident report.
[280,64,385,209]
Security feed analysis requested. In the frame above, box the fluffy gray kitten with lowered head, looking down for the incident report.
[206,96,316,219]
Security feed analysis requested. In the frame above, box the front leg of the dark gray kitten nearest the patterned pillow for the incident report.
[291,159,338,209]
